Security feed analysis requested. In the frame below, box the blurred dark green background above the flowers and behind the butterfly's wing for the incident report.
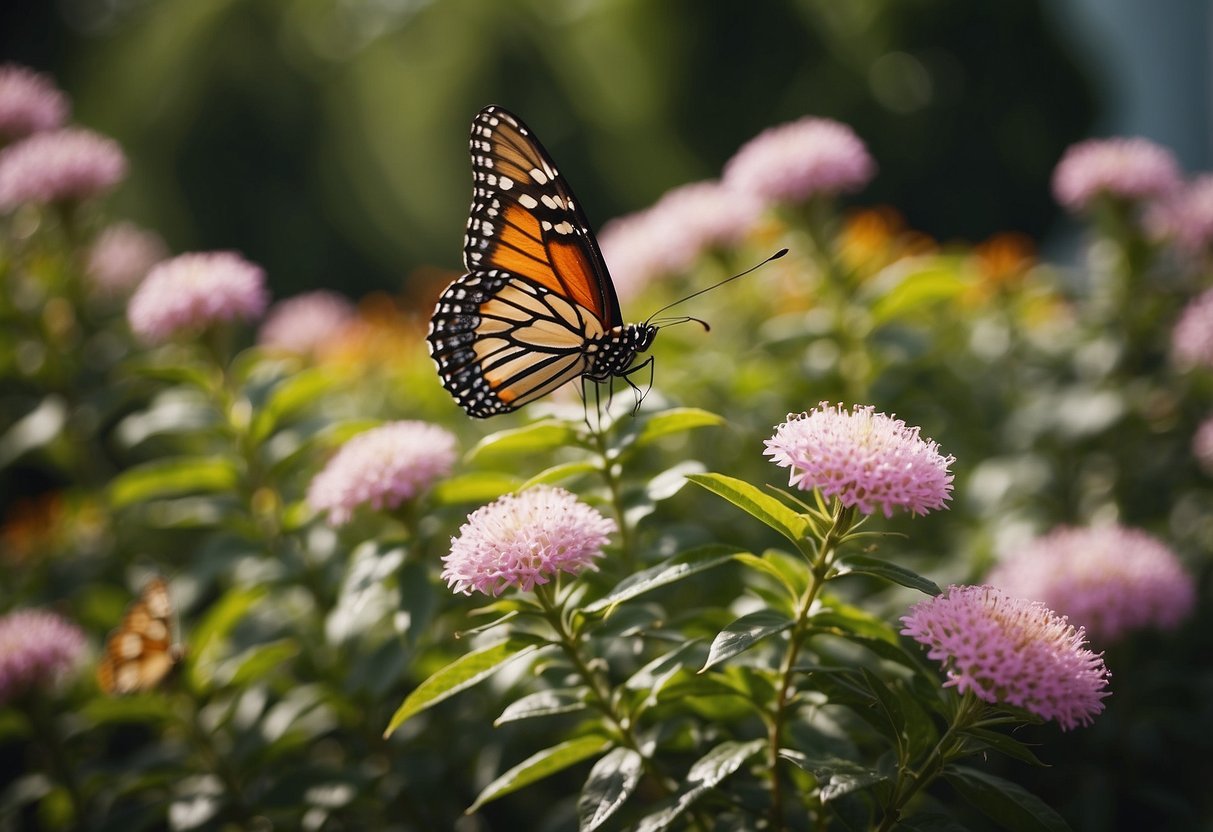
[0,0,1209,296]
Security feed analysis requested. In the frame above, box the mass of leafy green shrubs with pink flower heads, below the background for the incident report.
[0,60,1213,832]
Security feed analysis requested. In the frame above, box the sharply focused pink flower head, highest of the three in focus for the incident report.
[765,401,956,517]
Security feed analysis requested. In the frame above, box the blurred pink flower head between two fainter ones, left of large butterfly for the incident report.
[126,251,269,343]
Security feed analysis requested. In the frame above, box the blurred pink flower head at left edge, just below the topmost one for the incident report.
[0,127,126,211]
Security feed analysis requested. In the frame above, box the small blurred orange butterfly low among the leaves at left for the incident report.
[97,577,181,696]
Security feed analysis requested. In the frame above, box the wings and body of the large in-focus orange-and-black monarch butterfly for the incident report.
[427,107,657,417]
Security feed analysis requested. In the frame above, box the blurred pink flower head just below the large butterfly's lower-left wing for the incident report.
[307,421,455,525]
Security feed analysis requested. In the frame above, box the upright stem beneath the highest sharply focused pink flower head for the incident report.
[767,502,855,832]
